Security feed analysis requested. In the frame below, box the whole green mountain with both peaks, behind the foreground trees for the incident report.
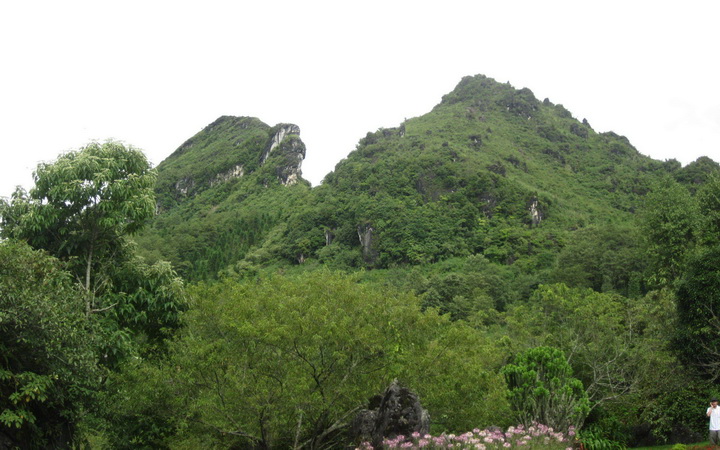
[138,75,717,291]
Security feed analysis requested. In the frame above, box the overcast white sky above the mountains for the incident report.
[0,0,720,196]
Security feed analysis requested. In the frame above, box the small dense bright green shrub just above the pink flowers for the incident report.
[503,347,590,430]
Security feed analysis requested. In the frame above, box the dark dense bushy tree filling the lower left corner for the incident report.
[0,241,100,448]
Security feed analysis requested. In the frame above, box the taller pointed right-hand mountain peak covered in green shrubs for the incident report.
[282,76,663,267]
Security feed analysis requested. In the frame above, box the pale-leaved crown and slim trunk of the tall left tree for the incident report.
[0,141,155,315]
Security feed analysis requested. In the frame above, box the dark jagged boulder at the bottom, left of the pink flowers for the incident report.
[352,380,430,448]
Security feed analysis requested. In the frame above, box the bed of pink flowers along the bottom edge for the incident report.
[358,423,575,450]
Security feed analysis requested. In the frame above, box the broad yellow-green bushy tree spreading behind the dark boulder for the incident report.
[102,272,504,448]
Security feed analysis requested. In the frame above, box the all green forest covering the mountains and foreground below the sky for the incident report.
[0,75,720,449]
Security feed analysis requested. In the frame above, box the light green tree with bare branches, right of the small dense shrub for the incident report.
[506,285,693,443]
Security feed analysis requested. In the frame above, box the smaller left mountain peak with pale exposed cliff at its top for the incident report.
[137,116,309,279]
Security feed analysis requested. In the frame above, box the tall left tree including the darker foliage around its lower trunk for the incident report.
[0,141,185,365]
